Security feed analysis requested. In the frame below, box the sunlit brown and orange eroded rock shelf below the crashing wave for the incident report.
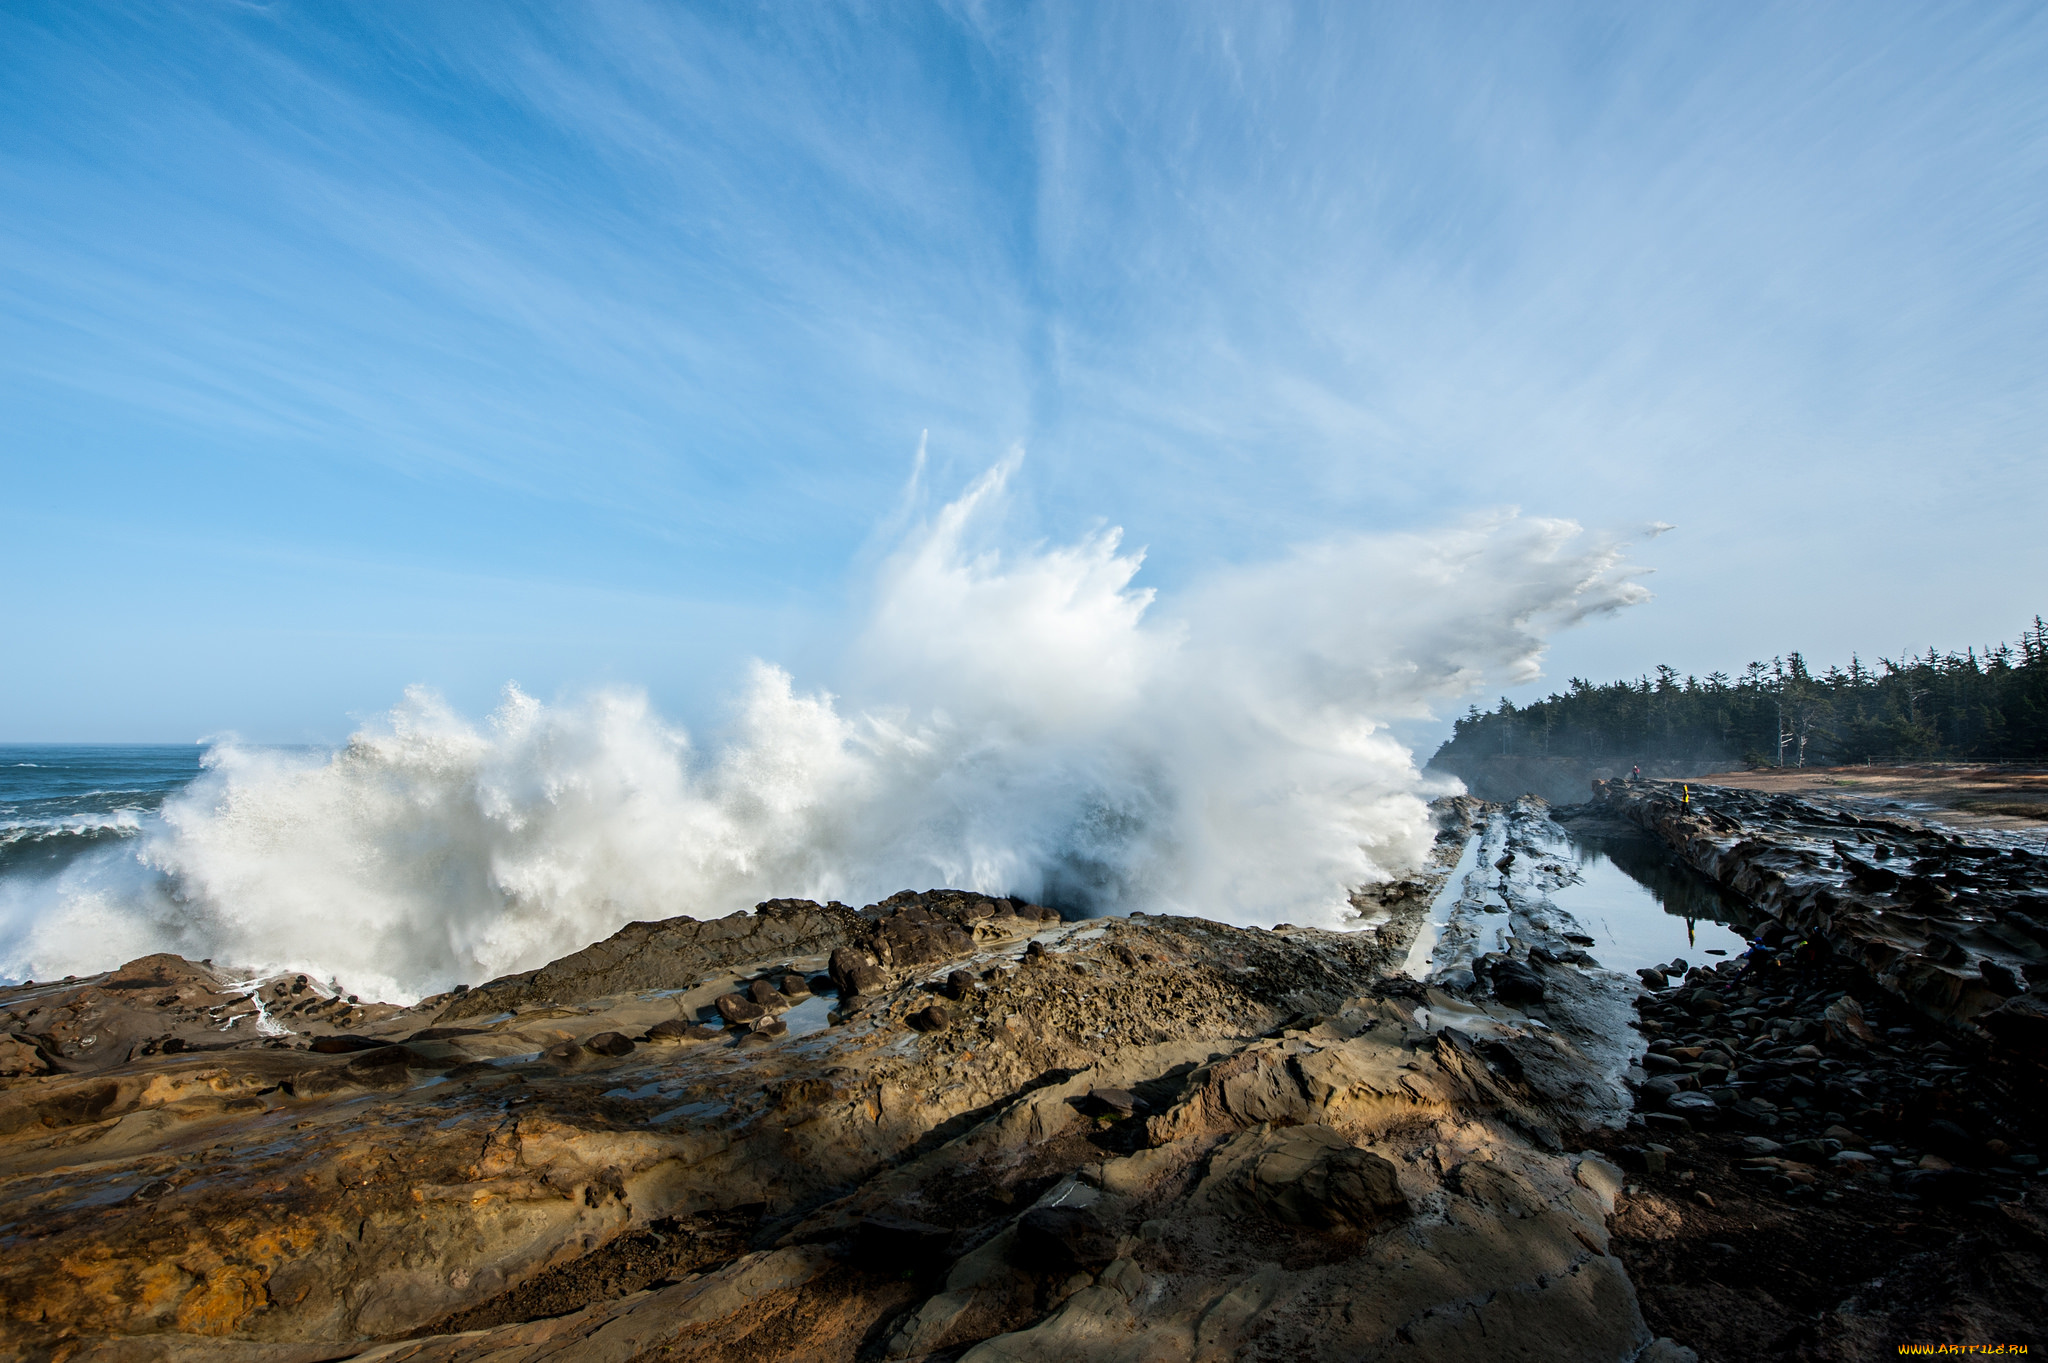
[0,835,1679,1363]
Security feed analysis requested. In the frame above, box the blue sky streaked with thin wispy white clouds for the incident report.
[0,2,2048,741]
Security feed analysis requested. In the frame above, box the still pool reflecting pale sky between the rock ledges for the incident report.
[1550,833,1749,974]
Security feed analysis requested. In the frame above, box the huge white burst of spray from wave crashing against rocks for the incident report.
[0,463,1645,999]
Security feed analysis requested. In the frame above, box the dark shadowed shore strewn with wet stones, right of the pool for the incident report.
[1559,782,2048,1359]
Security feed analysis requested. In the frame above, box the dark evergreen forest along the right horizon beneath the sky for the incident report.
[1434,616,2048,767]
